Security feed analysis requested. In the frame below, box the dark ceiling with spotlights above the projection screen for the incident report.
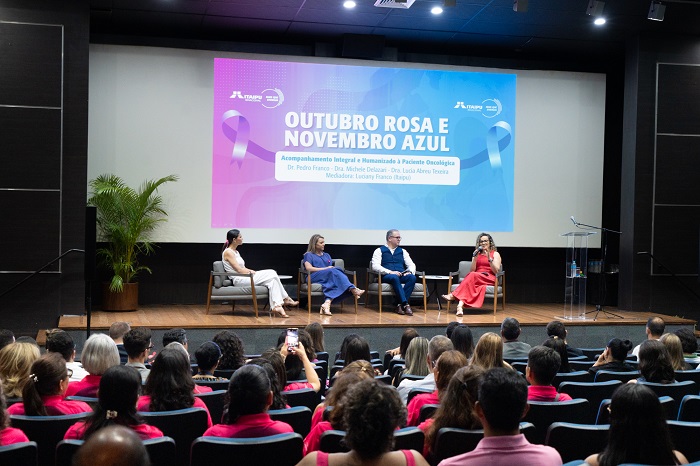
[90,0,700,59]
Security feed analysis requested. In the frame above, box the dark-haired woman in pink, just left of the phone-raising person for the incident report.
[204,365,294,438]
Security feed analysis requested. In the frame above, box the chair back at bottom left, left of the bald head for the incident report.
[10,412,92,465]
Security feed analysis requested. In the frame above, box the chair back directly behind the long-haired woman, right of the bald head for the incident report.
[139,408,208,466]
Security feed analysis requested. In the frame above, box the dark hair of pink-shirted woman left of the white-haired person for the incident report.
[22,353,68,416]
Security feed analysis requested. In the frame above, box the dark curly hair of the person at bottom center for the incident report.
[343,379,406,460]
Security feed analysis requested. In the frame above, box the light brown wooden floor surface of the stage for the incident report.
[58,303,695,330]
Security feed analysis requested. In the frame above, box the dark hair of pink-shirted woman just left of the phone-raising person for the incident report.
[224,364,271,424]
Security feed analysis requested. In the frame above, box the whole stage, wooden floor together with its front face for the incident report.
[58,302,695,354]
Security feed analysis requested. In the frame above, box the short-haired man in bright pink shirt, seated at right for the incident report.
[525,346,572,401]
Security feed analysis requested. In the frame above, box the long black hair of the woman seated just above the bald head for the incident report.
[83,365,143,440]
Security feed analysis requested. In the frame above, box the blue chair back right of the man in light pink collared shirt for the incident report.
[544,422,610,462]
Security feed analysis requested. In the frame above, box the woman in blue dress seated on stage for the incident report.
[304,234,365,316]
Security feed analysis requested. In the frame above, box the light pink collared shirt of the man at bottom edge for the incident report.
[439,434,562,466]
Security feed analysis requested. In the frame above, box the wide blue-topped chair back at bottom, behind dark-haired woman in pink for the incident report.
[190,433,304,466]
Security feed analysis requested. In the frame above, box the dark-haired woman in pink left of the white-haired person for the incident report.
[7,354,92,416]
